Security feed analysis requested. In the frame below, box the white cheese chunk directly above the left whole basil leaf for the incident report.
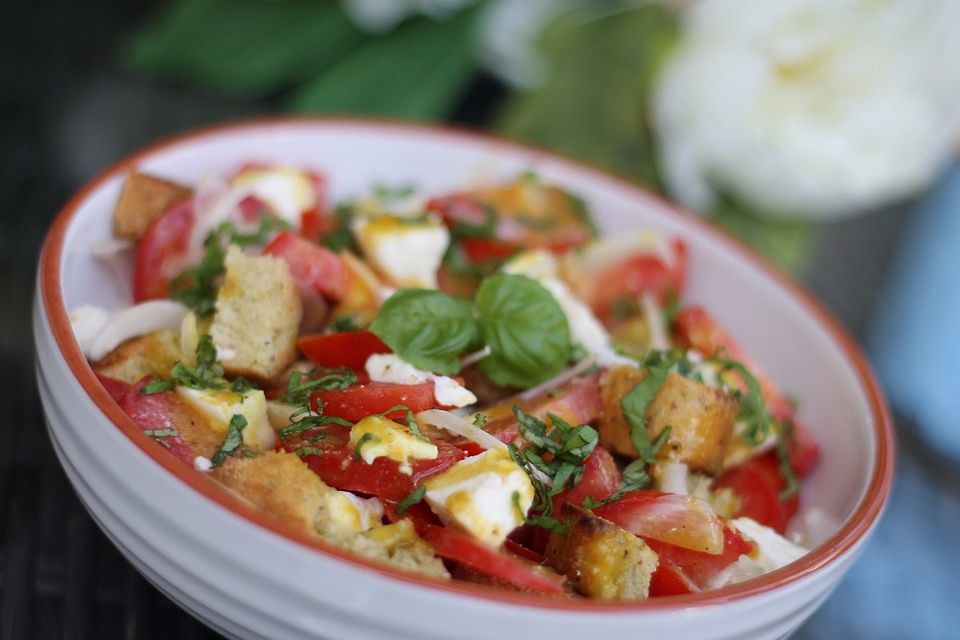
[353,215,450,289]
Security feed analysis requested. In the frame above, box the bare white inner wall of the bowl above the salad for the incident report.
[60,121,878,556]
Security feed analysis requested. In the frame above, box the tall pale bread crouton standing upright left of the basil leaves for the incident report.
[210,246,301,381]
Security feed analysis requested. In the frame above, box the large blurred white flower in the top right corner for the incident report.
[653,0,960,218]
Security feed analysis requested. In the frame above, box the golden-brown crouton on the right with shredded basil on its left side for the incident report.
[647,373,740,474]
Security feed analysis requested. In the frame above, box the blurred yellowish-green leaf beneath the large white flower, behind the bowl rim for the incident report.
[711,198,813,274]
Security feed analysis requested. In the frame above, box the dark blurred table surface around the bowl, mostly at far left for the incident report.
[0,0,944,640]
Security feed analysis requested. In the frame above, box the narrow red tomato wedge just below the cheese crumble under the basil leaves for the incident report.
[310,382,440,422]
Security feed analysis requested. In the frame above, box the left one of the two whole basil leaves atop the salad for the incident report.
[370,289,477,374]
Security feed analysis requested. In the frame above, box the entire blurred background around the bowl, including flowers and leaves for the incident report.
[0,0,960,640]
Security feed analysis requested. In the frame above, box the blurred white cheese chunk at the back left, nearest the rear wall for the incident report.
[233,165,317,227]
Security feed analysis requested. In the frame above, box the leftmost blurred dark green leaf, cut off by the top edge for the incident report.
[121,0,365,99]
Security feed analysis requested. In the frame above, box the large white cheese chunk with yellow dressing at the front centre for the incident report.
[423,449,534,547]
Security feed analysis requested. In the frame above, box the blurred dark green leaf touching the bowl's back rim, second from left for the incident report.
[289,9,477,119]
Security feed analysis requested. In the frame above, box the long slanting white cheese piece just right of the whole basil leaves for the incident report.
[503,250,636,367]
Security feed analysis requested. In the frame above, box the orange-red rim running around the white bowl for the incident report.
[38,116,895,613]
